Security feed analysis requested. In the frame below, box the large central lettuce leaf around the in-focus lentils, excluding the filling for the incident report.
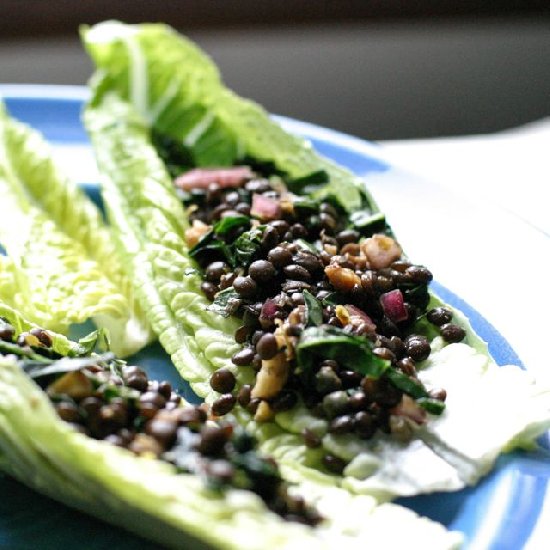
[83,22,550,500]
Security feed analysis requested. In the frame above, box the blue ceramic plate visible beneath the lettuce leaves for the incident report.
[0,86,550,550]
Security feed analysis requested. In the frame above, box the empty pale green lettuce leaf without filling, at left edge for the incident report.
[0,100,150,355]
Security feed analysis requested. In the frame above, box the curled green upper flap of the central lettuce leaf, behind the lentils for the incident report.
[81,21,378,212]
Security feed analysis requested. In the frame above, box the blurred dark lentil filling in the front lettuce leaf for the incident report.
[0,317,321,526]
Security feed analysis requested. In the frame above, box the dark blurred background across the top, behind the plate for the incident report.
[0,0,550,140]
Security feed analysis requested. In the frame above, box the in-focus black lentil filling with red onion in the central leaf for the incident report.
[170,166,465,473]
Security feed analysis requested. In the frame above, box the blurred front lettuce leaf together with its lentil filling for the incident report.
[0,303,459,548]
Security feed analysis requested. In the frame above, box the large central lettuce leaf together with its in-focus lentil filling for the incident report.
[83,17,548,508]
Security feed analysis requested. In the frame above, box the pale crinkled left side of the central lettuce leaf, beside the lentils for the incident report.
[85,94,239,396]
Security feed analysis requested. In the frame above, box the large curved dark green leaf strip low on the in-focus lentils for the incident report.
[297,325,390,378]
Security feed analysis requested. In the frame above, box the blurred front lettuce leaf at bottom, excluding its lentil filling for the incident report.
[0,357,461,550]
